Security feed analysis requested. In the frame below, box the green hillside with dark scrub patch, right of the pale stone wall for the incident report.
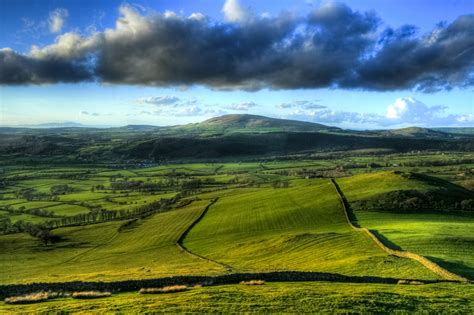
[338,172,474,279]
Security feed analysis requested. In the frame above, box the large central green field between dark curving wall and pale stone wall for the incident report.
[185,180,436,278]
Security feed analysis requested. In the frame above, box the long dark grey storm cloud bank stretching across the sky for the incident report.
[0,1,474,92]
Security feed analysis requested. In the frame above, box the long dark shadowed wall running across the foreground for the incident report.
[0,271,462,299]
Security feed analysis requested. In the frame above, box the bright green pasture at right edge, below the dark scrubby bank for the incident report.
[356,211,474,279]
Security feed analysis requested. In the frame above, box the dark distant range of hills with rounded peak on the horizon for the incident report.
[0,115,474,161]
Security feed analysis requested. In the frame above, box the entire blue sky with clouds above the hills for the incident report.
[0,0,474,129]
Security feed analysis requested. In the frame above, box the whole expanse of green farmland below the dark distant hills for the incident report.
[0,120,474,312]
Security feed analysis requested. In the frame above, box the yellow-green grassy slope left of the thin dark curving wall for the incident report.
[0,200,222,283]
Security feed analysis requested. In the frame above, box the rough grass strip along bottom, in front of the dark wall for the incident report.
[0,282,474,314]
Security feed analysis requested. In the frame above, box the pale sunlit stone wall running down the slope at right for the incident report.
[331,178,470,282]
